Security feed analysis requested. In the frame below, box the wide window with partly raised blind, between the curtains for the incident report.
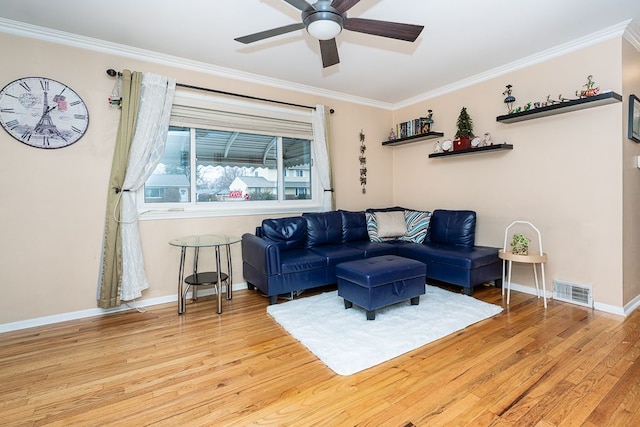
[141,90,321,215]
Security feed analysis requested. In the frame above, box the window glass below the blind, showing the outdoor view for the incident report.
[144,126,313,214]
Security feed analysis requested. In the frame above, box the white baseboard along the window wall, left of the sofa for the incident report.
[0,282,247,333]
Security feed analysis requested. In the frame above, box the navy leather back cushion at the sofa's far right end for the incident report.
[425,209,476,247]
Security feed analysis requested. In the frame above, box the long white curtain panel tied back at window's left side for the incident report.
[120,73,176,301]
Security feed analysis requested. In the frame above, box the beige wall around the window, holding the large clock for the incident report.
[0,34,393,324]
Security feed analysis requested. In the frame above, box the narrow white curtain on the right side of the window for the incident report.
[312,105,334,211]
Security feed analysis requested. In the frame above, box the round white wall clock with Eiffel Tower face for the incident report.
[0,77,89,148]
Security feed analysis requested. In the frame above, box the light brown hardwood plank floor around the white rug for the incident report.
[0,287,640,427]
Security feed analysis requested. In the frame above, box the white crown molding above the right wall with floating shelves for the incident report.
[393,20,640,110]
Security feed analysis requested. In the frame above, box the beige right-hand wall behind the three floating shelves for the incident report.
[393,39,637,307]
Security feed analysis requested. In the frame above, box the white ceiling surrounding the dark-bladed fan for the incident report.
[0,0,640,106]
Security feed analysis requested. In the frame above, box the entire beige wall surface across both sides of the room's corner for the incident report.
[0,30,640,324]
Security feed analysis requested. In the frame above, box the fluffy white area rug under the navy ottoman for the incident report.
[267,285,502,375]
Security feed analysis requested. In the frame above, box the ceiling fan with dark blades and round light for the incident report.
[234,0,424,68]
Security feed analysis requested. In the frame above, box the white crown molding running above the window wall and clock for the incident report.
[0,17,393,110]
